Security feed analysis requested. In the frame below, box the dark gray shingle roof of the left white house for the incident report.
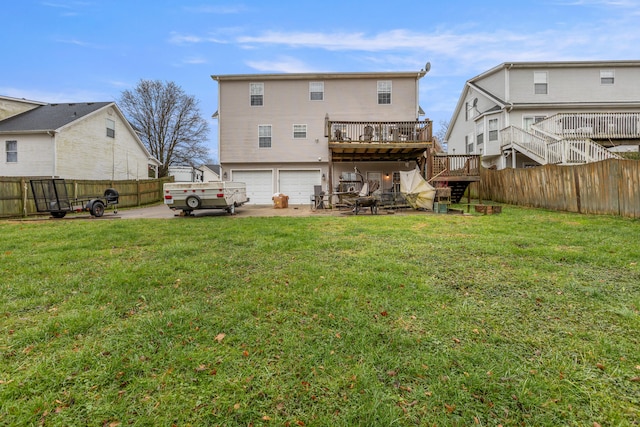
[0,102,113,132]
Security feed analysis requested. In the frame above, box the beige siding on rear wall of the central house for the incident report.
[219,76,417,164]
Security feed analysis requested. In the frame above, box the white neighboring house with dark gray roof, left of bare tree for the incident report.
[0,97,160,180]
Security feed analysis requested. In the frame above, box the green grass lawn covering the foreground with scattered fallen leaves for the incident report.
[0,206,640,427]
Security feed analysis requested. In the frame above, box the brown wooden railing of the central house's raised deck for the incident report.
[325,120,433,143]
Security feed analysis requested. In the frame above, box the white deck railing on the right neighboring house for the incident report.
[532,113,640,139]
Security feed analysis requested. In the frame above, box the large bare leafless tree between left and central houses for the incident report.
[118,80,209,177]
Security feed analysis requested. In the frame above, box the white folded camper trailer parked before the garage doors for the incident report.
[163,181,249,216]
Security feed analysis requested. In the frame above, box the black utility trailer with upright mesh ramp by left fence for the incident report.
[30,178,120,218]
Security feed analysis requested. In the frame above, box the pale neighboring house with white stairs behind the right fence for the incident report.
[445,61,640,169]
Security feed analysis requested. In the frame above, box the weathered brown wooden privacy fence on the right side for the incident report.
[480,159,640,218]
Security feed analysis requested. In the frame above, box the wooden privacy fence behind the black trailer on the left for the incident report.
[0,177,173,218]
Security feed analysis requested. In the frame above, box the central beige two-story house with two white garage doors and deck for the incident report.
[212,70,433,204]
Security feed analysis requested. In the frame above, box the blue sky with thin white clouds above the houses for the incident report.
[0,0,640,159]
